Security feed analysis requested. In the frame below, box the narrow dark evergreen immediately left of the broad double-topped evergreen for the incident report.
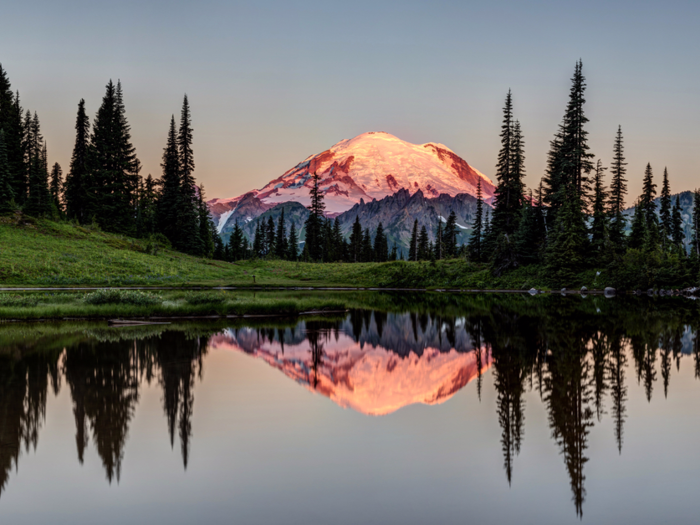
[63,99,90,224]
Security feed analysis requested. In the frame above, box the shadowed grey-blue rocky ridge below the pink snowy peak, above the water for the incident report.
[219,189,484,249]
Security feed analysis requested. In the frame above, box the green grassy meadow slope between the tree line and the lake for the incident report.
[0,217,604,289]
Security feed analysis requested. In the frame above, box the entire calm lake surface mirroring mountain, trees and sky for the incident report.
[0,294,700,524]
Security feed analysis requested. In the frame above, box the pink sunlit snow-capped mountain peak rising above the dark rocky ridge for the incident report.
[208,131,495,232]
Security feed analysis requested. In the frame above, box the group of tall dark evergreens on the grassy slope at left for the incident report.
[0,66,221,256]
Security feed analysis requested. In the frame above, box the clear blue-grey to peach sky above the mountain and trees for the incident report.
[0,0,700,204]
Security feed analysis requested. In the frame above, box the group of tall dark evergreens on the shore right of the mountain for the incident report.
[468,61,700,286]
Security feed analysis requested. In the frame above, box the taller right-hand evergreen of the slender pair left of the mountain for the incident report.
[173,95,203,254]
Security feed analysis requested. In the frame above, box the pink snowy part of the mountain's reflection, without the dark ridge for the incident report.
[210,329,491,416]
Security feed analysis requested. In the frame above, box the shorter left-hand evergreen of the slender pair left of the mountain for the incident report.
[157,115,183,248]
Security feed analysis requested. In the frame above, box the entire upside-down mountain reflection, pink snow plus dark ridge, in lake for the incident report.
[210,312,490,415]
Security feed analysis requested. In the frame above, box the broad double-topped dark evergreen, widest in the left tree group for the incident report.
[86,81,141,235]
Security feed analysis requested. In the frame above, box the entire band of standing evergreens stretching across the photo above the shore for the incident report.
[0,61,700,288]
